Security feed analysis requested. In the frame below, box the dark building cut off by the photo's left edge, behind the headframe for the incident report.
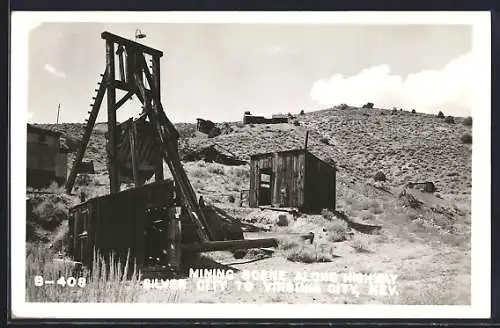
[26,124,69,188]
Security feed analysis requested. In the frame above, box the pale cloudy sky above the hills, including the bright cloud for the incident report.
[26,23,472,123]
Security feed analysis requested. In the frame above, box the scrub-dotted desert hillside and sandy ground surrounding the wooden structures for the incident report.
[27,106,472,304]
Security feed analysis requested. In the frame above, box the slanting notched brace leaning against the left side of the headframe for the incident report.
[66,68,108,194]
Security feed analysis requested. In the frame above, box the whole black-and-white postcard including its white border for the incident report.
[10,12,491,318]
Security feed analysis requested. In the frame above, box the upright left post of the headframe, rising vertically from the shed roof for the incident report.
[106,41,120,194]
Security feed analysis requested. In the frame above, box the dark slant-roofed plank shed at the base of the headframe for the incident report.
[69,180,174,267]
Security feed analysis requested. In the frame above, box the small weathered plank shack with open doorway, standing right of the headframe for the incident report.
[249,149,336,212]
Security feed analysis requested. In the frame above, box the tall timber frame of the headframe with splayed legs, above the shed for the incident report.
[66,32,213,242]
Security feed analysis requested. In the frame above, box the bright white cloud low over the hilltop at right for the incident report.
[311,53,475,116]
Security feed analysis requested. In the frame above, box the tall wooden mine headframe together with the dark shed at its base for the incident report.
[66,32,277,273]
